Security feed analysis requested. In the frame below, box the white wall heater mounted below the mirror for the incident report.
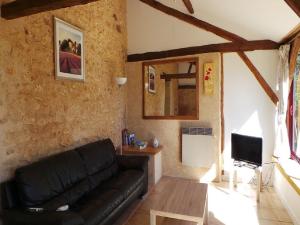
[181,127,214,168]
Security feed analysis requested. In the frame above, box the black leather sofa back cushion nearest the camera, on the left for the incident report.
[16,151,87,207]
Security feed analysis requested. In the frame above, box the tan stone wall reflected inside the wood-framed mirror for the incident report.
[141,63,178,116]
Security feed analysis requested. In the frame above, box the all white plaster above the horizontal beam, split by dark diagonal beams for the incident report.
[127,0,300,54]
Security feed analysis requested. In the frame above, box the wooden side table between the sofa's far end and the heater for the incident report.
[121,145,162,186]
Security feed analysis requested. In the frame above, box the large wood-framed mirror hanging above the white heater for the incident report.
[142,58,199,120]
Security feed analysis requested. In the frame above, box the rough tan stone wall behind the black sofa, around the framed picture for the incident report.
[0,0,127,181]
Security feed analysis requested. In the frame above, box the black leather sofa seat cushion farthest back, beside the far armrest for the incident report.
[100,170,145,198]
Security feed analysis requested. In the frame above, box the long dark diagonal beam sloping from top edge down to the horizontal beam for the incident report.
[140,0,246,42]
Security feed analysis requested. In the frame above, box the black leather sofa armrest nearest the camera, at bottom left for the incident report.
[3,209,84,225]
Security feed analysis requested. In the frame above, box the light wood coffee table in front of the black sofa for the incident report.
[150,178,208,225]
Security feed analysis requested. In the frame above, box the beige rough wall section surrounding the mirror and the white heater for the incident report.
[126,53,221,182]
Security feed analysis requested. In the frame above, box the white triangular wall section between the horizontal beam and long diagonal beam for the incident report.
[127,0,227,54]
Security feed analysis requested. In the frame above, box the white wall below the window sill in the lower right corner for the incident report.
[274,168,300,225]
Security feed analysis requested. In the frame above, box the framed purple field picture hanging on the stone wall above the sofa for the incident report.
[54,17,85,81]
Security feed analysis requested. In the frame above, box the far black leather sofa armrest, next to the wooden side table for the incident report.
[117,155,149,172]
